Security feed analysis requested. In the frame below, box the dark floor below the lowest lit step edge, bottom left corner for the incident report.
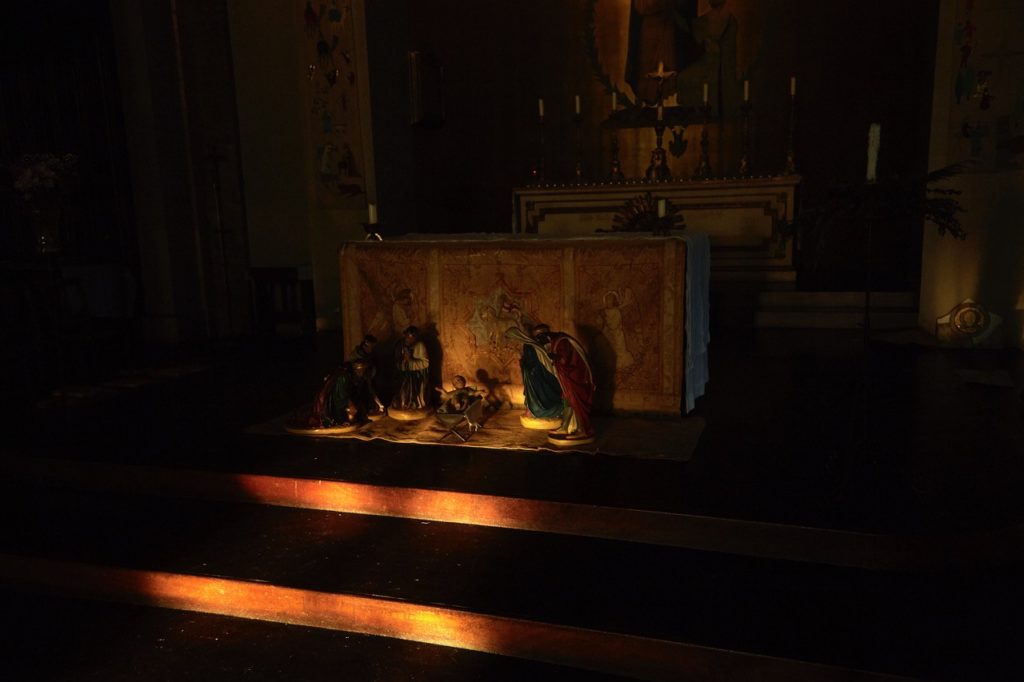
[0,589,629,682]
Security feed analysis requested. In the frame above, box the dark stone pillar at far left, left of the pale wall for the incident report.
[110,0,258,343]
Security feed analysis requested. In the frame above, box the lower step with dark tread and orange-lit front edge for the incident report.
[0,485,999,680]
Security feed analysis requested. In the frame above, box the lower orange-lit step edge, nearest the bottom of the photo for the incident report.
[0,554,910,682]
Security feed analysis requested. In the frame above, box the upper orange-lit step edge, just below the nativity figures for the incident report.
[6,456,1024,572]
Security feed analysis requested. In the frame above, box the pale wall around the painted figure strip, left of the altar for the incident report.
[227,0,374,329]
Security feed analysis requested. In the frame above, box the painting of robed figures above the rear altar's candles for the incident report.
[584,0,765,177]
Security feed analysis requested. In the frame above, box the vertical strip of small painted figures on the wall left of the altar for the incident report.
[297,0,366,208]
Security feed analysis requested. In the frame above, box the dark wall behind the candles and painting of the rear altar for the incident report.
[370,0,938,290]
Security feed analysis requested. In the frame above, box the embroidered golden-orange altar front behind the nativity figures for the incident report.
[340,235,707,416]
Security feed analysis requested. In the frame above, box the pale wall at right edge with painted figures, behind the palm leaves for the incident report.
[919,0,1024,347]
